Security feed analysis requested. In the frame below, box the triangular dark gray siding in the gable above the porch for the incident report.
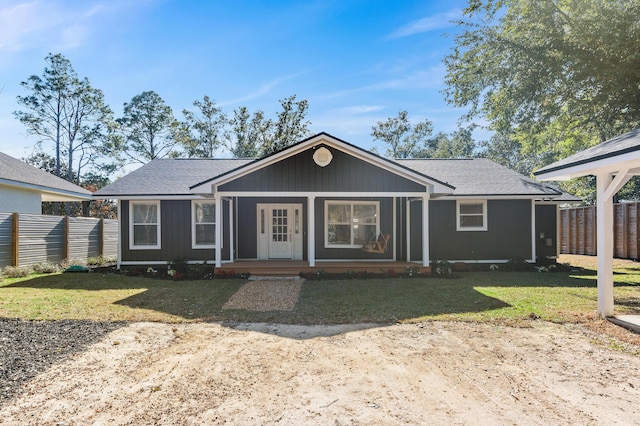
[219,148,425,192]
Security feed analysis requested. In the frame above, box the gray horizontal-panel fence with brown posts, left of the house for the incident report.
[0,213,118,267]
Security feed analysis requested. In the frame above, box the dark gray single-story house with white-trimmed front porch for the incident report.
[94,133,575,267]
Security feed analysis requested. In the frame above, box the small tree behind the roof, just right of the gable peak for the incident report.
[371,110,433,158]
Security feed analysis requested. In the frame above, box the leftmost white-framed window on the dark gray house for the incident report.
[129,200,160,250]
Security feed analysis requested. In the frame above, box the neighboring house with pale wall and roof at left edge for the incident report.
[0,152,91,214]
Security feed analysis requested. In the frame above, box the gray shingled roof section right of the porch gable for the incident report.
[396,158,562,198]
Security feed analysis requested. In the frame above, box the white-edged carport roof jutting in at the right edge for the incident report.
[533,128,640,180]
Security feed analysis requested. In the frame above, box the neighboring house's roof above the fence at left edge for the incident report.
[0,152,91,201]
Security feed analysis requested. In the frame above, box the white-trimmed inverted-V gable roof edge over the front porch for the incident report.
[191,132,454,193]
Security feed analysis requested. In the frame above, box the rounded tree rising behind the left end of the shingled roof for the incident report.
[180,96,227,158]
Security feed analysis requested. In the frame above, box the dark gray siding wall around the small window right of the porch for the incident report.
[411,200,532,260]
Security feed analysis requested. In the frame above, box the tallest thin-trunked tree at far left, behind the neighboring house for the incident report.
[14,53,113,183]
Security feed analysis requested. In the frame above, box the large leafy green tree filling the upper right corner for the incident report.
[445,0,640,143]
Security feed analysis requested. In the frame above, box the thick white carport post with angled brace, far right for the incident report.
[596,169,632,318]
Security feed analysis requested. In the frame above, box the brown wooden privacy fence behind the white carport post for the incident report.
[560,203,640,259]
